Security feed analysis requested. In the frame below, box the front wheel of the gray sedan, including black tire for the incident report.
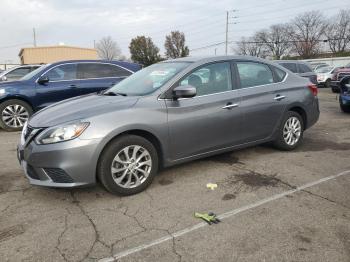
[97,135,158,195]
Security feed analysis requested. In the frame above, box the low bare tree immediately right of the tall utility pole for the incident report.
[234,35,267,58]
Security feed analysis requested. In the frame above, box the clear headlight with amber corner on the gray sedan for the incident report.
[35,122,89,145]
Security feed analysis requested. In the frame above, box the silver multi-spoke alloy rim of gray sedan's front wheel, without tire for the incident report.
[111,145,152,188]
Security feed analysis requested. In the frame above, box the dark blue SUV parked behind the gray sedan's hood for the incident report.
[0,60,141,131]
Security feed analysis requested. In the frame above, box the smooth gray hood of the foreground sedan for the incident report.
[28,94,138,127]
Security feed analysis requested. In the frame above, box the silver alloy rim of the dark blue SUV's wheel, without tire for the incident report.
[1,104,29,128]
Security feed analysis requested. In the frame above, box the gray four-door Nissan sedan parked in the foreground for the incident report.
[18,56,319,195]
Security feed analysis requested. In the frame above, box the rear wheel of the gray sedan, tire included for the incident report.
[274,111,304,151]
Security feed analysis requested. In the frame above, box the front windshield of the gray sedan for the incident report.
[105,62,190,96]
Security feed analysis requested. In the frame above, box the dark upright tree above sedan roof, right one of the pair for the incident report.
[164,31,190,58]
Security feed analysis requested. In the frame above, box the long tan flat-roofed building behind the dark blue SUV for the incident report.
[18,45,97,64]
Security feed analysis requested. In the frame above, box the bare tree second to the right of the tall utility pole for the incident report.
[256,24,292,59]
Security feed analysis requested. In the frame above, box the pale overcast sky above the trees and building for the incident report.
[0,0,350,63]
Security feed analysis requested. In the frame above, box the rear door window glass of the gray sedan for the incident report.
[237,62,274,88]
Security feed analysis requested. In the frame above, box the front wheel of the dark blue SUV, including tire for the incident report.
[0,99,33,131]
